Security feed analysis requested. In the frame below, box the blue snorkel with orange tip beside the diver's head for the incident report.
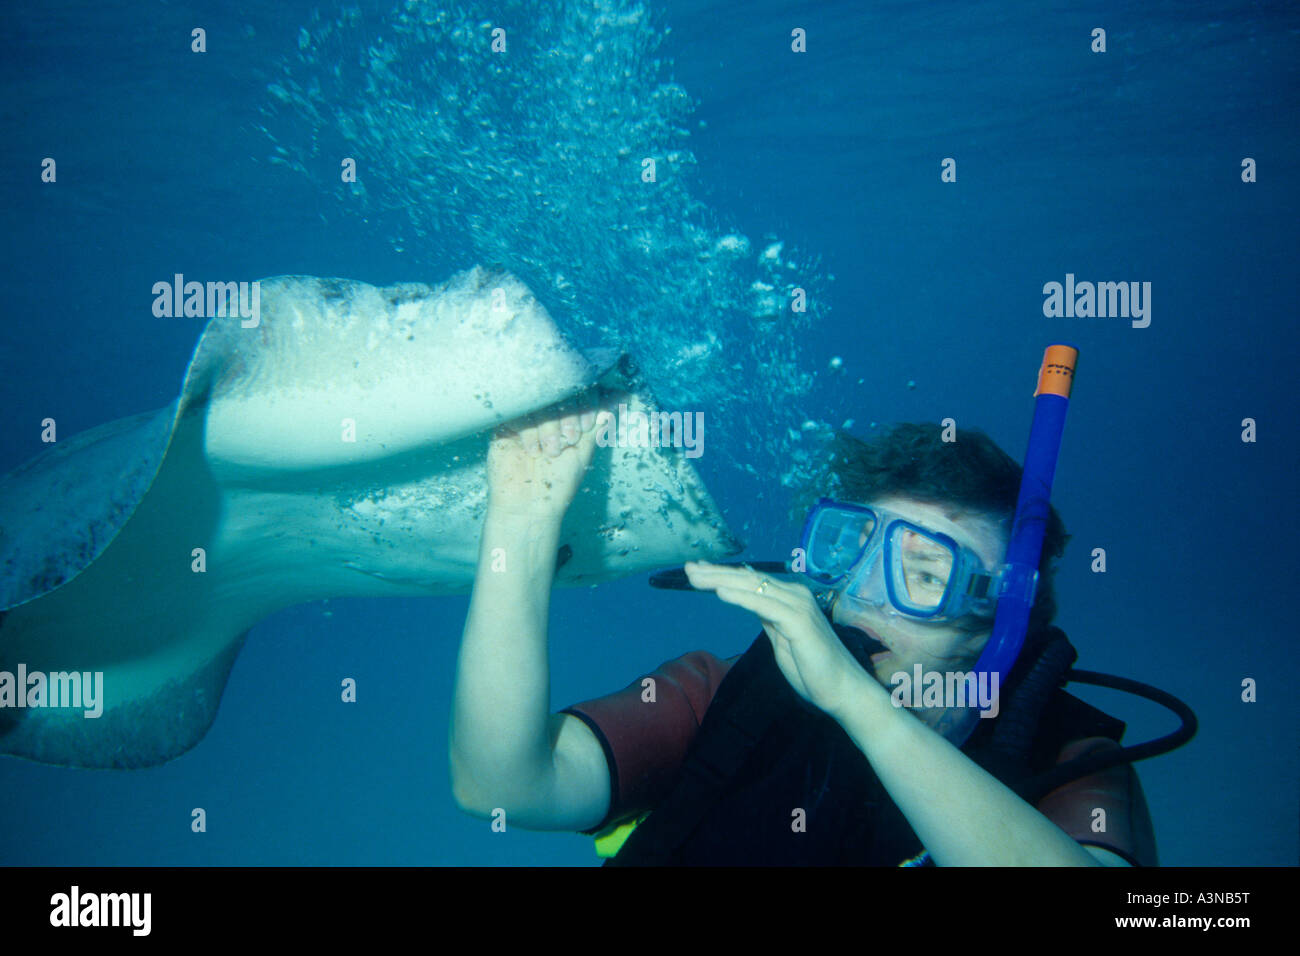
[939,345,1079,747]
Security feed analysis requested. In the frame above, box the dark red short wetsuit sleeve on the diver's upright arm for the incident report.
[560,650,732,832]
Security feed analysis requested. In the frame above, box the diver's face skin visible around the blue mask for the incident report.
[832,497,1006,687]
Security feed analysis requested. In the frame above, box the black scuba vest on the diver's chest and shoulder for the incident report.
[606,627,1125,866]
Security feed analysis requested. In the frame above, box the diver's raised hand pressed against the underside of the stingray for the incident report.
[488,406,612,522]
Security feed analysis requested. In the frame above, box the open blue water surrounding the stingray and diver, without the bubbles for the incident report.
[0,1,1300,865]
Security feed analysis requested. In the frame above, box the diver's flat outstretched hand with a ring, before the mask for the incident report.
[685,561,866,717]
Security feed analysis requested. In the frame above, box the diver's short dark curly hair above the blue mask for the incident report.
[794,423,1070,633]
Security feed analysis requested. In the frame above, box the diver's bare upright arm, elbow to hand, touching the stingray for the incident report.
[450,415,610,830]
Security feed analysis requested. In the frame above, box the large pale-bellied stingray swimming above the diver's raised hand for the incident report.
[0,268,741,767]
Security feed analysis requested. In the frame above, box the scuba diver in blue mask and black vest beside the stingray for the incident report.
[450,377,1195,866]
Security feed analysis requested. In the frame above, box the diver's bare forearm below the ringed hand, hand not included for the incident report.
[831,669,1126,866]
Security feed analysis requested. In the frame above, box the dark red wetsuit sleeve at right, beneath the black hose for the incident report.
[1039,737,1160,866]
